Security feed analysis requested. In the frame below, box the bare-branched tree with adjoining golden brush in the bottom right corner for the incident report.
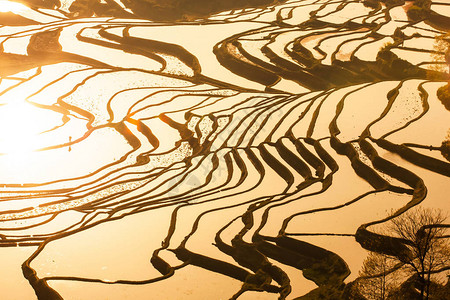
[352,208,450,300]
